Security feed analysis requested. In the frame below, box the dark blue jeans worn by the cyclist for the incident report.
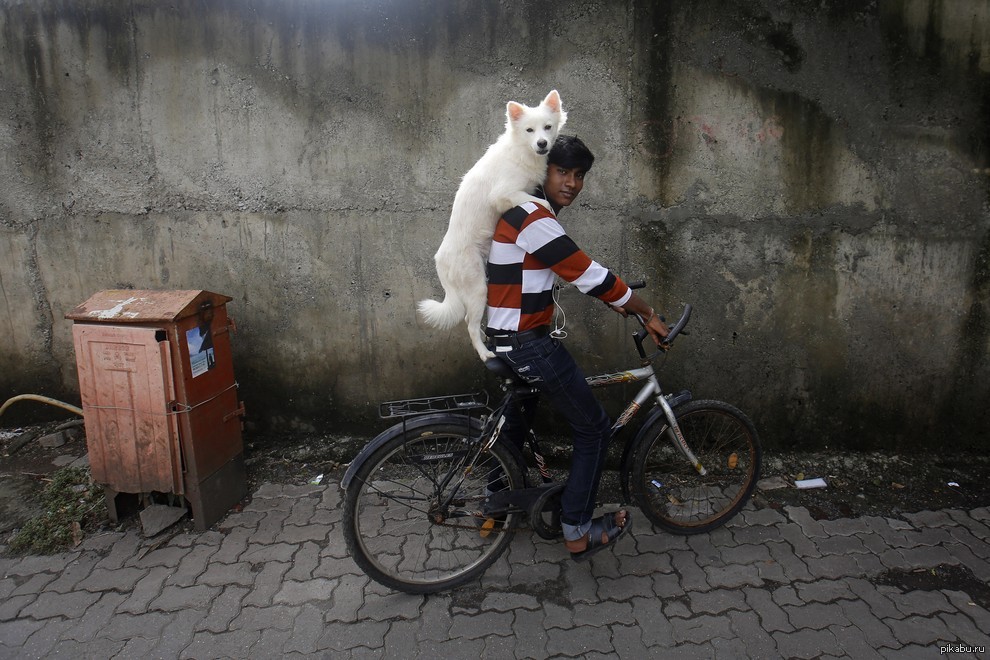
[499,337,611,540]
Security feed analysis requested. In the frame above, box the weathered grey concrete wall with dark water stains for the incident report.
[0,0,990,448]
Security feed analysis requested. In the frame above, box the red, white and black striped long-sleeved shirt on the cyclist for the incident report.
[488,202,632,334]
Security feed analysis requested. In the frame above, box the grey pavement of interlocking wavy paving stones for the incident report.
[0,484,990,660]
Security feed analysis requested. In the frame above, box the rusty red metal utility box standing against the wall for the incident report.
[65,289,247,531]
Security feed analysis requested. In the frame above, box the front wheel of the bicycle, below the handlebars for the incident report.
[631,400,762,534]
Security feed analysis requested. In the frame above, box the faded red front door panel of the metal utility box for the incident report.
[72,323,184,493]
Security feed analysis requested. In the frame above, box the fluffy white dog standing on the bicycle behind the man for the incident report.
[418,90,567,361]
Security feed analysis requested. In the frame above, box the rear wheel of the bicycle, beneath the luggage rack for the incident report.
[342,416,523,594]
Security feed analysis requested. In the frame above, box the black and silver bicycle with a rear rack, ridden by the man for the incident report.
[341,283,761,594]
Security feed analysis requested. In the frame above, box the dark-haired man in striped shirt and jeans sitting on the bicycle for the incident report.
[486,135,668,561]
